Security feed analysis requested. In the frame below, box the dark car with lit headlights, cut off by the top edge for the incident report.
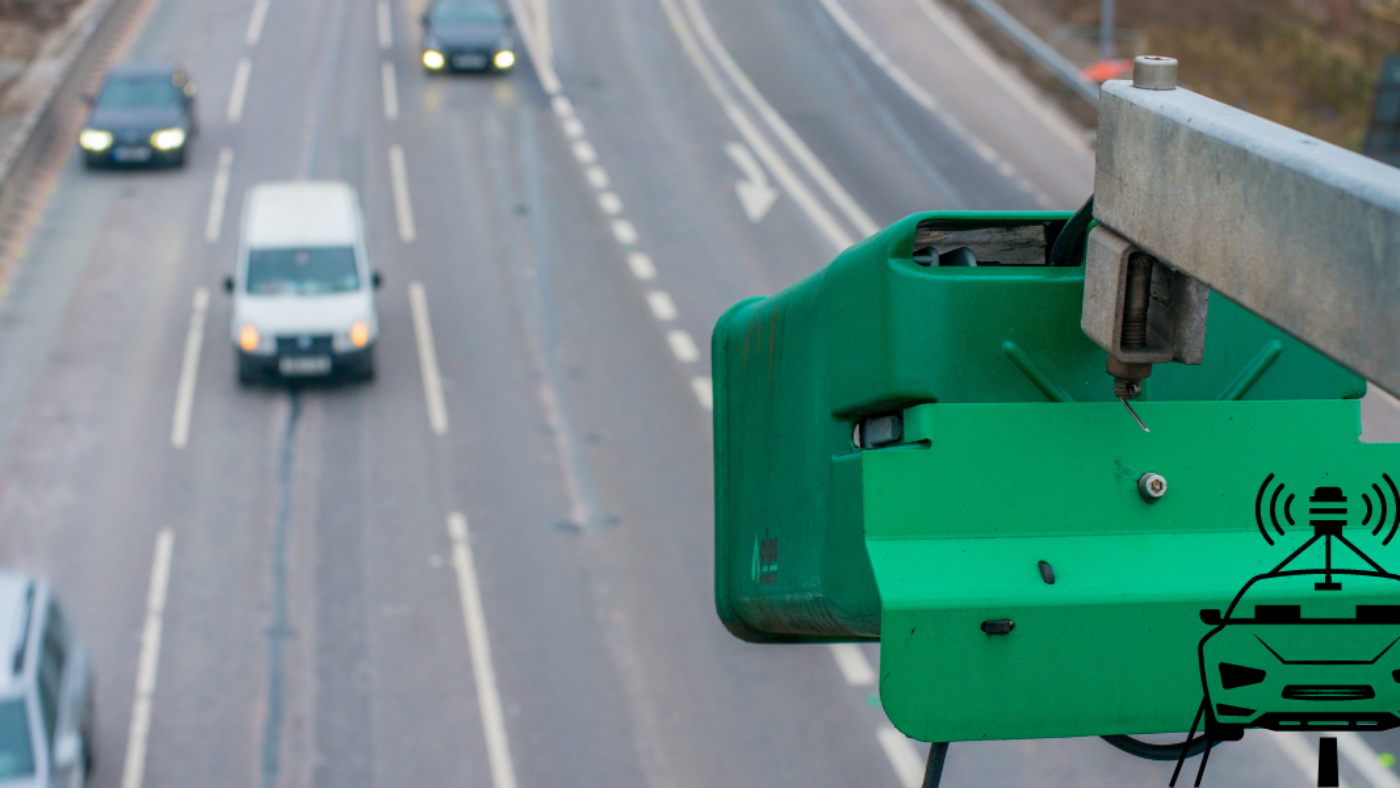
[423,0,515,71]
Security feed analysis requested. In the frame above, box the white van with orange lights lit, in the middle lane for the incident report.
[224,181,379,384]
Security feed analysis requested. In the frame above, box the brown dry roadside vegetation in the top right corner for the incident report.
[952,0,1400,148]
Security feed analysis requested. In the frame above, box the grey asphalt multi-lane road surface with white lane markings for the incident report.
[0,0,1400,788]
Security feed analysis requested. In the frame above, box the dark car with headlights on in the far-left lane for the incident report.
[78,63,199,167]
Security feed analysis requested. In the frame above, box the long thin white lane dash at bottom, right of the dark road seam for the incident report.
[447,512,515,788]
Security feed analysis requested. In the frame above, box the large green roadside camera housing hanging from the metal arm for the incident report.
[713,213,1400,740]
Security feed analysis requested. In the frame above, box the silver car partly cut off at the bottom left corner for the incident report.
[0,572,95,788]
